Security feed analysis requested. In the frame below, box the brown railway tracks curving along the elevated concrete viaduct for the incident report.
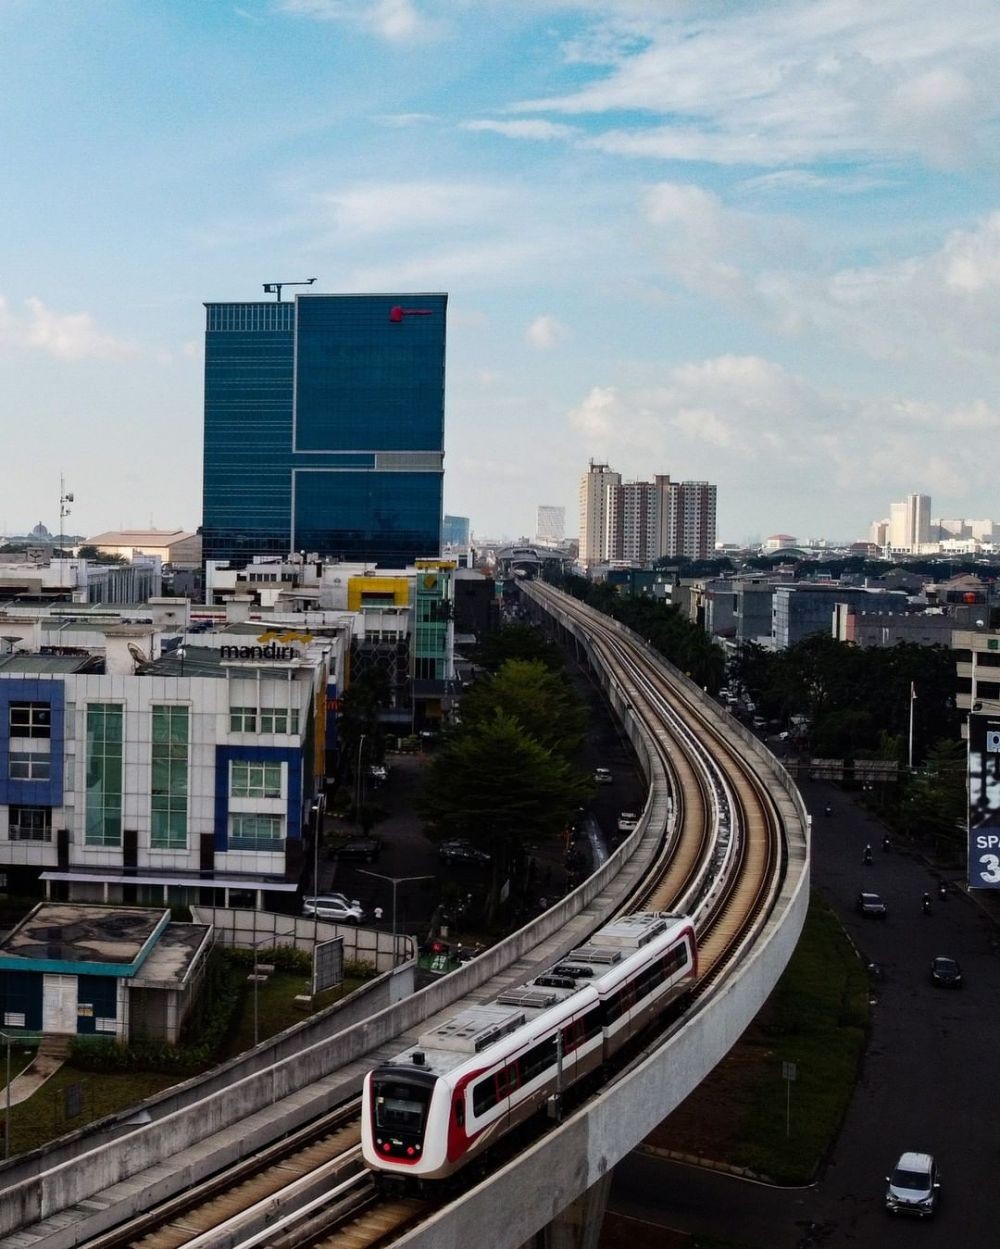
[70,585,799,1249]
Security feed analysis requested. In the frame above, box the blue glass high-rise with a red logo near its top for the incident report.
[202,295,447,567]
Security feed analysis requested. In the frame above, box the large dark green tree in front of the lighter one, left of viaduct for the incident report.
[417,709,593,923]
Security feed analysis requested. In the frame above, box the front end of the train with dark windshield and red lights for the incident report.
[361,1055,448,1177]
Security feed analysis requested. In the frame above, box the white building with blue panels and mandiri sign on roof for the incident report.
[0,626,343,909]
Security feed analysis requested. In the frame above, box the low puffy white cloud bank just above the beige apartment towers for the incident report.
[568,355,1000,536]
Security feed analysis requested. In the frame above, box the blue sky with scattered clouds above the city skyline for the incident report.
[0,0,1000,542]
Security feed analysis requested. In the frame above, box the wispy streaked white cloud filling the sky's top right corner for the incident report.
[514,0,1000,167]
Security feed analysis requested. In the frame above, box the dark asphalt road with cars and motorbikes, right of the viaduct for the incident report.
[609,782,1000,1249]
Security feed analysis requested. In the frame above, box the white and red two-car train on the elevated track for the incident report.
[361,913,698,1180]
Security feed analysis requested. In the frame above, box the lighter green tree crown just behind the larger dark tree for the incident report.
[462,659,587,761]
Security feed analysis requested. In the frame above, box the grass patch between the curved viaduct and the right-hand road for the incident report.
[649,894,869,1184]
